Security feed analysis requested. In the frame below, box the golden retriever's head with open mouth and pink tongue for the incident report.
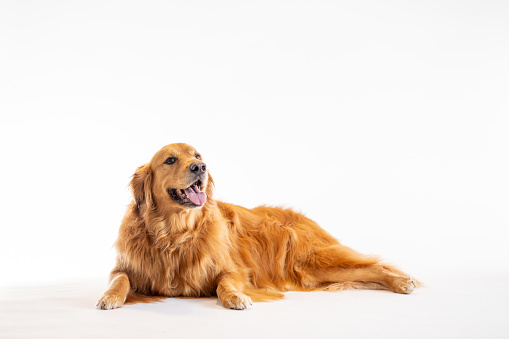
[131,144,213,211]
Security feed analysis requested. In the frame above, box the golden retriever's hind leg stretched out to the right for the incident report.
[305,245,418,294]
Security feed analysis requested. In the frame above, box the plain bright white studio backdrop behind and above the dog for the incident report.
[0,1,509,338]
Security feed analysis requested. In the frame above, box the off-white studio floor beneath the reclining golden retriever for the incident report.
[0,275,509,339]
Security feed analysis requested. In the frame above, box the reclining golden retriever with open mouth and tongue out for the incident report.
[97,144,419,310]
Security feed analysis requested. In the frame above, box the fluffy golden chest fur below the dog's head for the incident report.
[116,205,231,297]
